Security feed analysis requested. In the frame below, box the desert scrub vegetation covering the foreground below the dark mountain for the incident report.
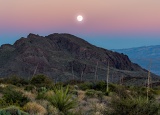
[0,75,160,115]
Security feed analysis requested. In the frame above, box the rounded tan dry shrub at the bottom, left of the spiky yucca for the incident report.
[23,102,47,115]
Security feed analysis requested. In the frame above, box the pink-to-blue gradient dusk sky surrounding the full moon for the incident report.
[0,0,160,49]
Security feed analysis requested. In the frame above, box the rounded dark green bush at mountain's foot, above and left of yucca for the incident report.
[31,75,53,88]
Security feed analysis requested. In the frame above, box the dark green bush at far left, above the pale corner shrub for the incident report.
[2,88,29,106]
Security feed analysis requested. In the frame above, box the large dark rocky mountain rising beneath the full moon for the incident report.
[0,33,158,82]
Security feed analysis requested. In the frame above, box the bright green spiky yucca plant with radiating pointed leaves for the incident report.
[49,86,77,114]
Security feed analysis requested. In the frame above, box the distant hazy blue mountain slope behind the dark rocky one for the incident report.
[114,45,160,75]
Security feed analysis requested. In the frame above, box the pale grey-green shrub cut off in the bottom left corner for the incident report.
[0,106,29,115]
